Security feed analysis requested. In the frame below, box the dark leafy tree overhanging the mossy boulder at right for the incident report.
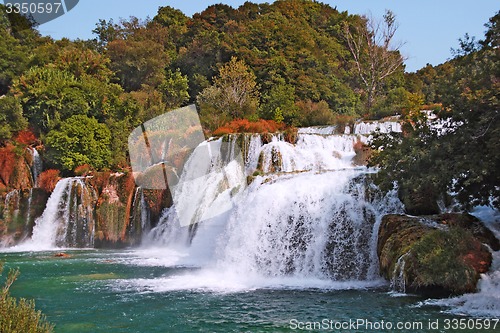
[372,13,500,209]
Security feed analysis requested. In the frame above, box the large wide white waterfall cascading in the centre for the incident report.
[148,122,402,281]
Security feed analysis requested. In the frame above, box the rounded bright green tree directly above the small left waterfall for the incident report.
[45,115,112,171]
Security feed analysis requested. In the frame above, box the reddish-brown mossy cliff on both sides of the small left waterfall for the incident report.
[0,158,171,248]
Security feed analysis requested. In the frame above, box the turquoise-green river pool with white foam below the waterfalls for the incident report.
[0,250,494,332]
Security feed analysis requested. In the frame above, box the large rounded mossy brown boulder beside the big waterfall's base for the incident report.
[377,214,500,296]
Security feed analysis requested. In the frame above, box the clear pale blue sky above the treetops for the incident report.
[39,0,500,71]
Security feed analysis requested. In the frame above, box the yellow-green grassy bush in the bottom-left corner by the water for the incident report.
[0,263,54,333]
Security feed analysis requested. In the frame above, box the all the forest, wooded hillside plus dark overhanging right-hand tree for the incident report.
[0,0,500,208]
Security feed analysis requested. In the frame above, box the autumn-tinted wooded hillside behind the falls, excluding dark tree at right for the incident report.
[0,0,408,173]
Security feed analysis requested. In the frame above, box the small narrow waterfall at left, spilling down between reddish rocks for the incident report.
[25,177,95,250]
